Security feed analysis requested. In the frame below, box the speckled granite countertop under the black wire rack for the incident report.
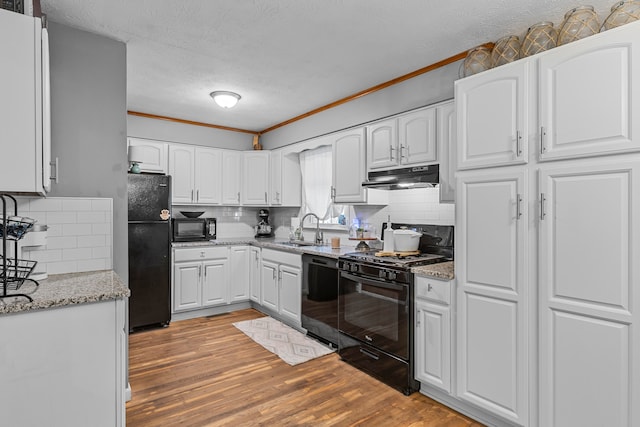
[0,270,131,315]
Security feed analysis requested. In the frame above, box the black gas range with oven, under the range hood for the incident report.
[338,224,453,395]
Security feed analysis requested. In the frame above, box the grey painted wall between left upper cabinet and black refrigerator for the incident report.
[47,21,129,283]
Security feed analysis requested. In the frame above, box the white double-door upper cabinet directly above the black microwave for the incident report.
[169,144,221,205]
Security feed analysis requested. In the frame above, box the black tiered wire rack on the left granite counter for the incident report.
[0,194,39,302]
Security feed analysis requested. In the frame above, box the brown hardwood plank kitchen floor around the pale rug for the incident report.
[127,309,481,427]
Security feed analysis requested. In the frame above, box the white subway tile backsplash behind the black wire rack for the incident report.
[11,197,113,274]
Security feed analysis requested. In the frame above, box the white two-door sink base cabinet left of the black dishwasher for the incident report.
[260,249,302,326]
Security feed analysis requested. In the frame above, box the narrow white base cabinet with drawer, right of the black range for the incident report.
[415,276,453,393]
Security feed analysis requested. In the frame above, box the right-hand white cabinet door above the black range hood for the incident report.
[398,107,438,165]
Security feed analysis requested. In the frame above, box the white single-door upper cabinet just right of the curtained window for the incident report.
[332,128,367,203]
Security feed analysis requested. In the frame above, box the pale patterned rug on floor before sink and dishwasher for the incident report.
[233,316,333,366]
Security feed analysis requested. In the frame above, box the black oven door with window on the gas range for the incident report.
[338,271,411,360]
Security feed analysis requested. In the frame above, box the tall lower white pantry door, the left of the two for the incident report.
[456,167,530,425]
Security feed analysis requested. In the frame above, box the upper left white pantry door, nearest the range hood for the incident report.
[455,59,531,169]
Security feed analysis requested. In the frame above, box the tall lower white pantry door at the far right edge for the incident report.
[538,155,640,427]
